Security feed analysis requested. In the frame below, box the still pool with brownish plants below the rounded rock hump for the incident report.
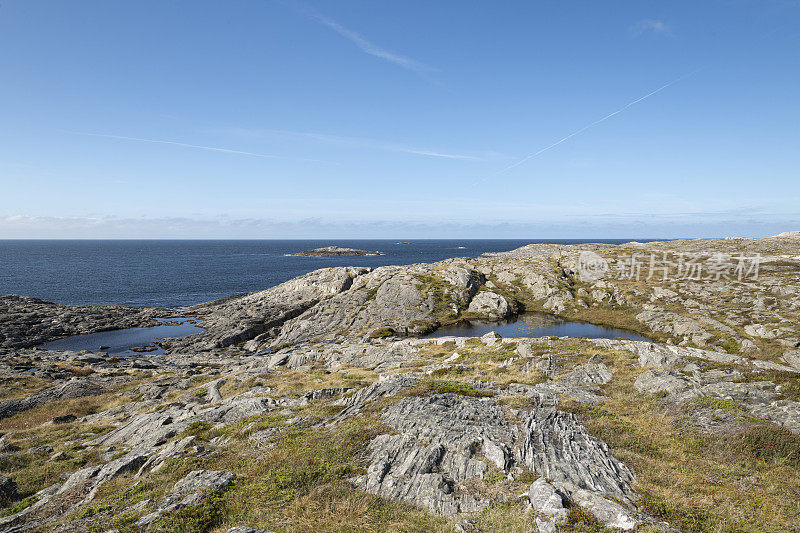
[427,313,650,341]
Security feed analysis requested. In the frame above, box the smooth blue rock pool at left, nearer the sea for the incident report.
[39,317,203,355]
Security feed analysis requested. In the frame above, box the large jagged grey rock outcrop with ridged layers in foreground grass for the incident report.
[354,394,636,516]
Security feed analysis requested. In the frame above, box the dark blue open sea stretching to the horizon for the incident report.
[0,239,648,307]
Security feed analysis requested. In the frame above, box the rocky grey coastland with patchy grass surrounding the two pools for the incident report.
[0,238,800,533]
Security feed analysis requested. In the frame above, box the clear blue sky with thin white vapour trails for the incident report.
[0,0,800,238]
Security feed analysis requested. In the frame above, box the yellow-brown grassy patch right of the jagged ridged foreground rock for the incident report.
[573,352,800,532]
